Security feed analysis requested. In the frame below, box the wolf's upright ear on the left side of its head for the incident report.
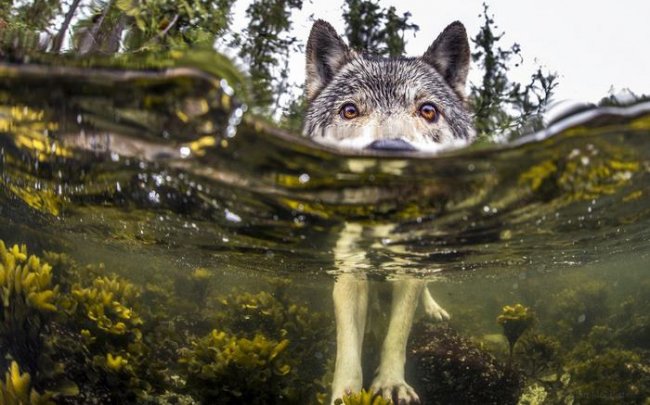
[305,20,352,100]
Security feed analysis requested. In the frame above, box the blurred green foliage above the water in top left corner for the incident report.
[0,0,235,55]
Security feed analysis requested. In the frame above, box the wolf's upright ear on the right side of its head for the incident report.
[422,21,469,99]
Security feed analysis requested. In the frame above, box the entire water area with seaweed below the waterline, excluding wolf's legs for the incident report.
[0,57,650,405]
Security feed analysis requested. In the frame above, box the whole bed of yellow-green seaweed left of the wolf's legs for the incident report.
[0,241,342,405]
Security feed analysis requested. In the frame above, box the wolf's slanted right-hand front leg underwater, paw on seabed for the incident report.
[371,280,425,405]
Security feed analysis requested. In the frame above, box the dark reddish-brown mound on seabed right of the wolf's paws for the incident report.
[407,322,524,405]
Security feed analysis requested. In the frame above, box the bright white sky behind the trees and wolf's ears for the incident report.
[227,0,650,102]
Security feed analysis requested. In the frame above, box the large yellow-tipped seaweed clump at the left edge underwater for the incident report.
[0,241,170,403]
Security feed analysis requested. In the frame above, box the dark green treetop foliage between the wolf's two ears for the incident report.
[343,0,419,56]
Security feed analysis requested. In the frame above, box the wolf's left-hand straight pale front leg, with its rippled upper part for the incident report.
[332,223,368,403]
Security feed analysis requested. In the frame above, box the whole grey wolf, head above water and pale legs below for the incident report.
[304,21,474,404]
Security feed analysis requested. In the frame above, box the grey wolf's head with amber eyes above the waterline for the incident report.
[303,20,474,151]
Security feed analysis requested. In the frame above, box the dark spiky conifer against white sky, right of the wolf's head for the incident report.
[469,3,557,139]
